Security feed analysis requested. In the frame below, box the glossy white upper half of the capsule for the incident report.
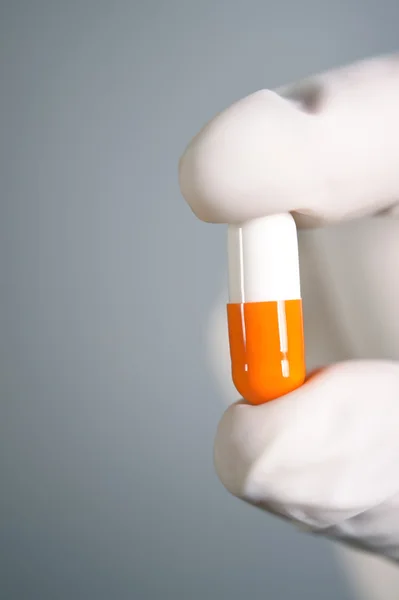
[228,213,301,303]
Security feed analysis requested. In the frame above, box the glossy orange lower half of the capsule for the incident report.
[227,299,306,404]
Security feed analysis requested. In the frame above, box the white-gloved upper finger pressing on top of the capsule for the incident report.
[179,57,399,226]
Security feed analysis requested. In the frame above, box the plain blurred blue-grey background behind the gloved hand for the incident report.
[0,0,399,600]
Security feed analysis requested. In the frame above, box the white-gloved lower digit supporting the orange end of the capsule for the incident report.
[214,361,399,561]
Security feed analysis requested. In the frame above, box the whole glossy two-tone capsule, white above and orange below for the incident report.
[227,214,306,404]
